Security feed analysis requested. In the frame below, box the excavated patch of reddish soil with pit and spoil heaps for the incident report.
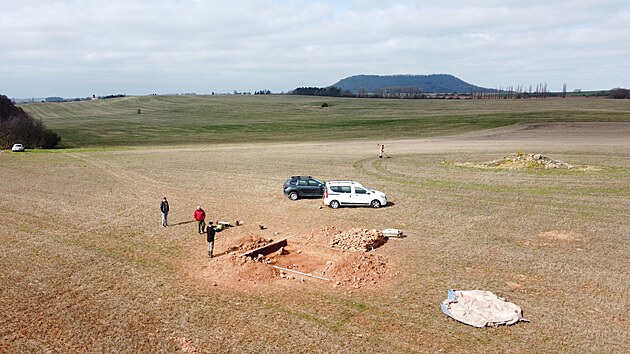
[183,227,398,289]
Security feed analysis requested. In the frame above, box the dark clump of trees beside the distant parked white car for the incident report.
[0,95,61,149]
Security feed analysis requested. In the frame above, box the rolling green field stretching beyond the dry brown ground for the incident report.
[22,95,630,147]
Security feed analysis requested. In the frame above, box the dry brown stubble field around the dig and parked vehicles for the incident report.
[0,122,630,353]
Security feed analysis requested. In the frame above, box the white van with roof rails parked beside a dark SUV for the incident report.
[324,181,387,209]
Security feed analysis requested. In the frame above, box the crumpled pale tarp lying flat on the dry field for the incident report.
[441,289,529,327]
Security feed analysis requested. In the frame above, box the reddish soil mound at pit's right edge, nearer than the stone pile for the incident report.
[330,252,393,288]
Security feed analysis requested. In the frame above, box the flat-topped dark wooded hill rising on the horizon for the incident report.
[331,74,493,93]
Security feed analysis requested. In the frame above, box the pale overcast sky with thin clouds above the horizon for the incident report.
[0,0,630,98]
